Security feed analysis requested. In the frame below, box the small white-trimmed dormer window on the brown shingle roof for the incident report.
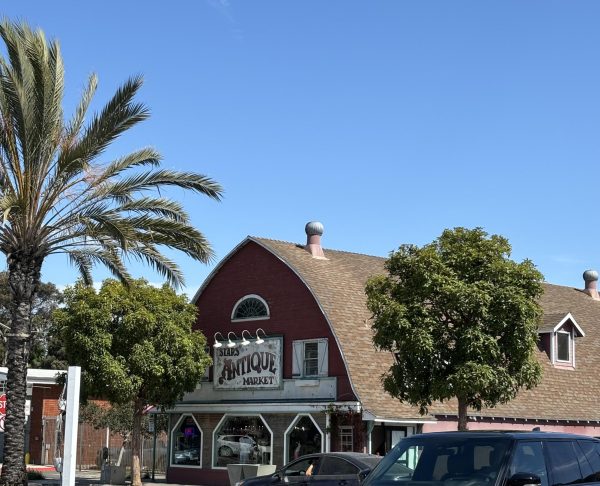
[539,313,585,368]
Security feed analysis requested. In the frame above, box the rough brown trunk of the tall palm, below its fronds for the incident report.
[0,253,42,486]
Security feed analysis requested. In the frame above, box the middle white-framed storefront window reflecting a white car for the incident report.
[213,415,273,467]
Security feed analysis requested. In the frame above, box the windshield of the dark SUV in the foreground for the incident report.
[366,434,510,486]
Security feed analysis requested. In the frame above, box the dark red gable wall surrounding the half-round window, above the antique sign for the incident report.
[196,242,356,400]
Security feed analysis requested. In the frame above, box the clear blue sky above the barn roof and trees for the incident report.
[3,0,600,294]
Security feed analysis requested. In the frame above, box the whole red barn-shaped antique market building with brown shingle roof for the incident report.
[167,223,600,485]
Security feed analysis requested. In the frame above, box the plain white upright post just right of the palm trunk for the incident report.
[61,366,81,486]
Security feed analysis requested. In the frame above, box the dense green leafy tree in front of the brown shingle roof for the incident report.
[366,228,543,430]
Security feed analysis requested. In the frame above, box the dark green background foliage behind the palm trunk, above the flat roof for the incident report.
[0,272,66,369]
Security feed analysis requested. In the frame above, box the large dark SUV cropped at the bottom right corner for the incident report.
[363,432,600,486]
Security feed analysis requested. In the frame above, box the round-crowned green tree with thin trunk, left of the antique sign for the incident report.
[55,280,211,485]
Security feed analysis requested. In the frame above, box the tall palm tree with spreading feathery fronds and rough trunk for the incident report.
[0,20,221,485]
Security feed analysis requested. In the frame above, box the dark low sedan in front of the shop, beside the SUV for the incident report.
[236,452,382,486]
